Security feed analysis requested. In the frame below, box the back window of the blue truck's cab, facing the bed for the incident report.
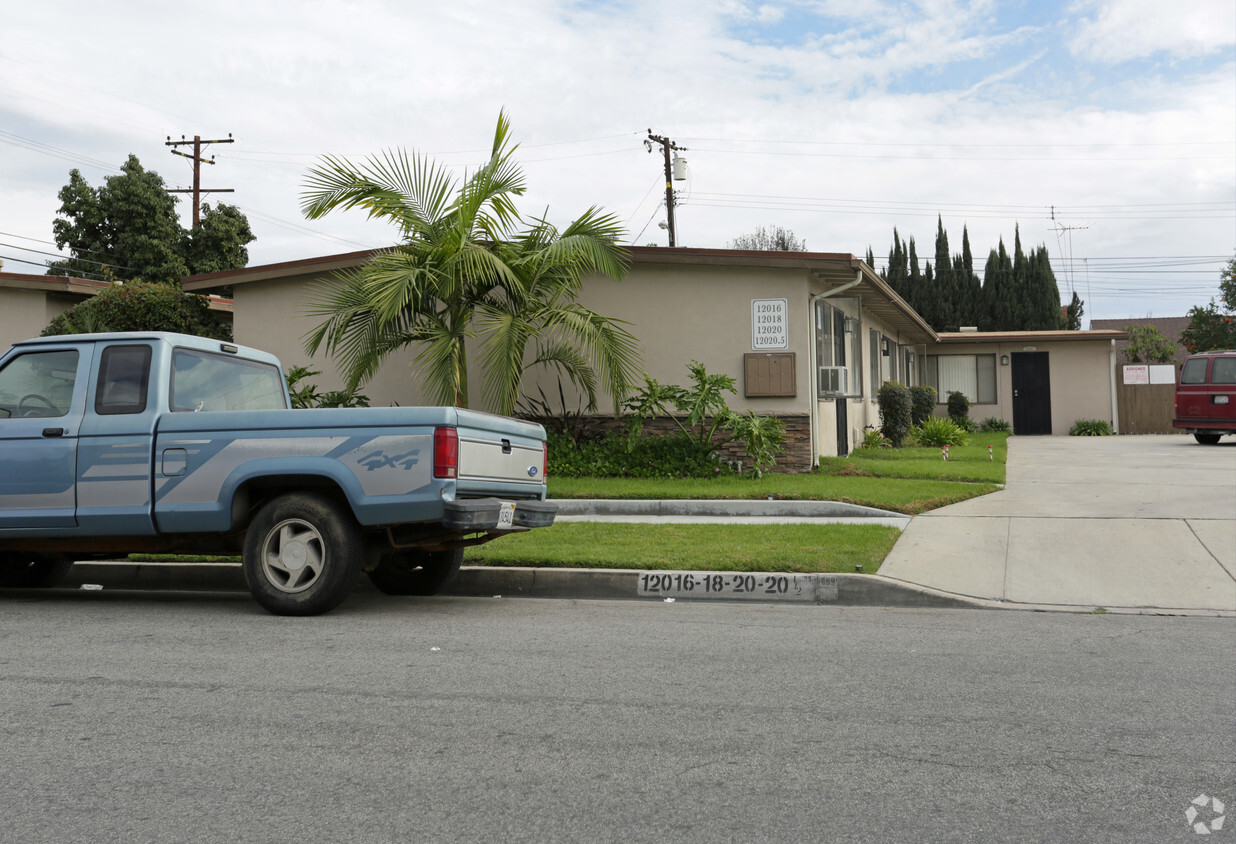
[172,348,288,411]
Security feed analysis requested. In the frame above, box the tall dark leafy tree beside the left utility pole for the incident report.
[48,156,253,283]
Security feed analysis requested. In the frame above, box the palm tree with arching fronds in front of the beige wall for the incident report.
[303,112,639,414]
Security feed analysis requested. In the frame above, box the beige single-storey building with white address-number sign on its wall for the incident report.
[184,247,1125,470]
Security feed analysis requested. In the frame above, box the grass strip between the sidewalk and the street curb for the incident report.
[464,521,901,573]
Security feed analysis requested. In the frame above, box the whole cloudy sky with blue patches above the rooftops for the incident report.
[0,0,1236,319]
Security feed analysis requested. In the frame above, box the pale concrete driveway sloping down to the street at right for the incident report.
[880,435,1236,612]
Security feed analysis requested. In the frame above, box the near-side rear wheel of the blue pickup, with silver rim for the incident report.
[242,493,365,615]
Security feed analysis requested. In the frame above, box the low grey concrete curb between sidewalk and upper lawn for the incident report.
[550,498,910,519]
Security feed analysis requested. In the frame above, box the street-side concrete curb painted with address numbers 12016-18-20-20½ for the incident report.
[61,562,984,608]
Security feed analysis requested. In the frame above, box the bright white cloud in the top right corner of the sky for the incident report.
[1069,0,1236,63]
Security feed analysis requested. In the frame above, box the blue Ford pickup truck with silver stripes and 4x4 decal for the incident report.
[0,332,556,615]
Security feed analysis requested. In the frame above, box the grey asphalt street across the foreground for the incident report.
[0,591,1236,843]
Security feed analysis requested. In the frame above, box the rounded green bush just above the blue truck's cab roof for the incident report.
[43,282,232,340]
